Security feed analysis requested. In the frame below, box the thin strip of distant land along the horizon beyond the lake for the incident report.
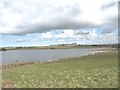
[0,44,118,51]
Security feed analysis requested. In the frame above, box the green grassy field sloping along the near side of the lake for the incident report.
[2,51,118,88]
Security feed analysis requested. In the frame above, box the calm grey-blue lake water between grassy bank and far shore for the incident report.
[0,48,104,64]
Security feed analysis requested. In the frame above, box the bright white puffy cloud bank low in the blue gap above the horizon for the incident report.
[41,29,97,41]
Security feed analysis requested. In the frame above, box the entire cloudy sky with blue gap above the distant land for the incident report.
[0,0,119,47]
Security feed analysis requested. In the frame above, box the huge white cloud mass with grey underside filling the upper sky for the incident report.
[0,0,117,35]
